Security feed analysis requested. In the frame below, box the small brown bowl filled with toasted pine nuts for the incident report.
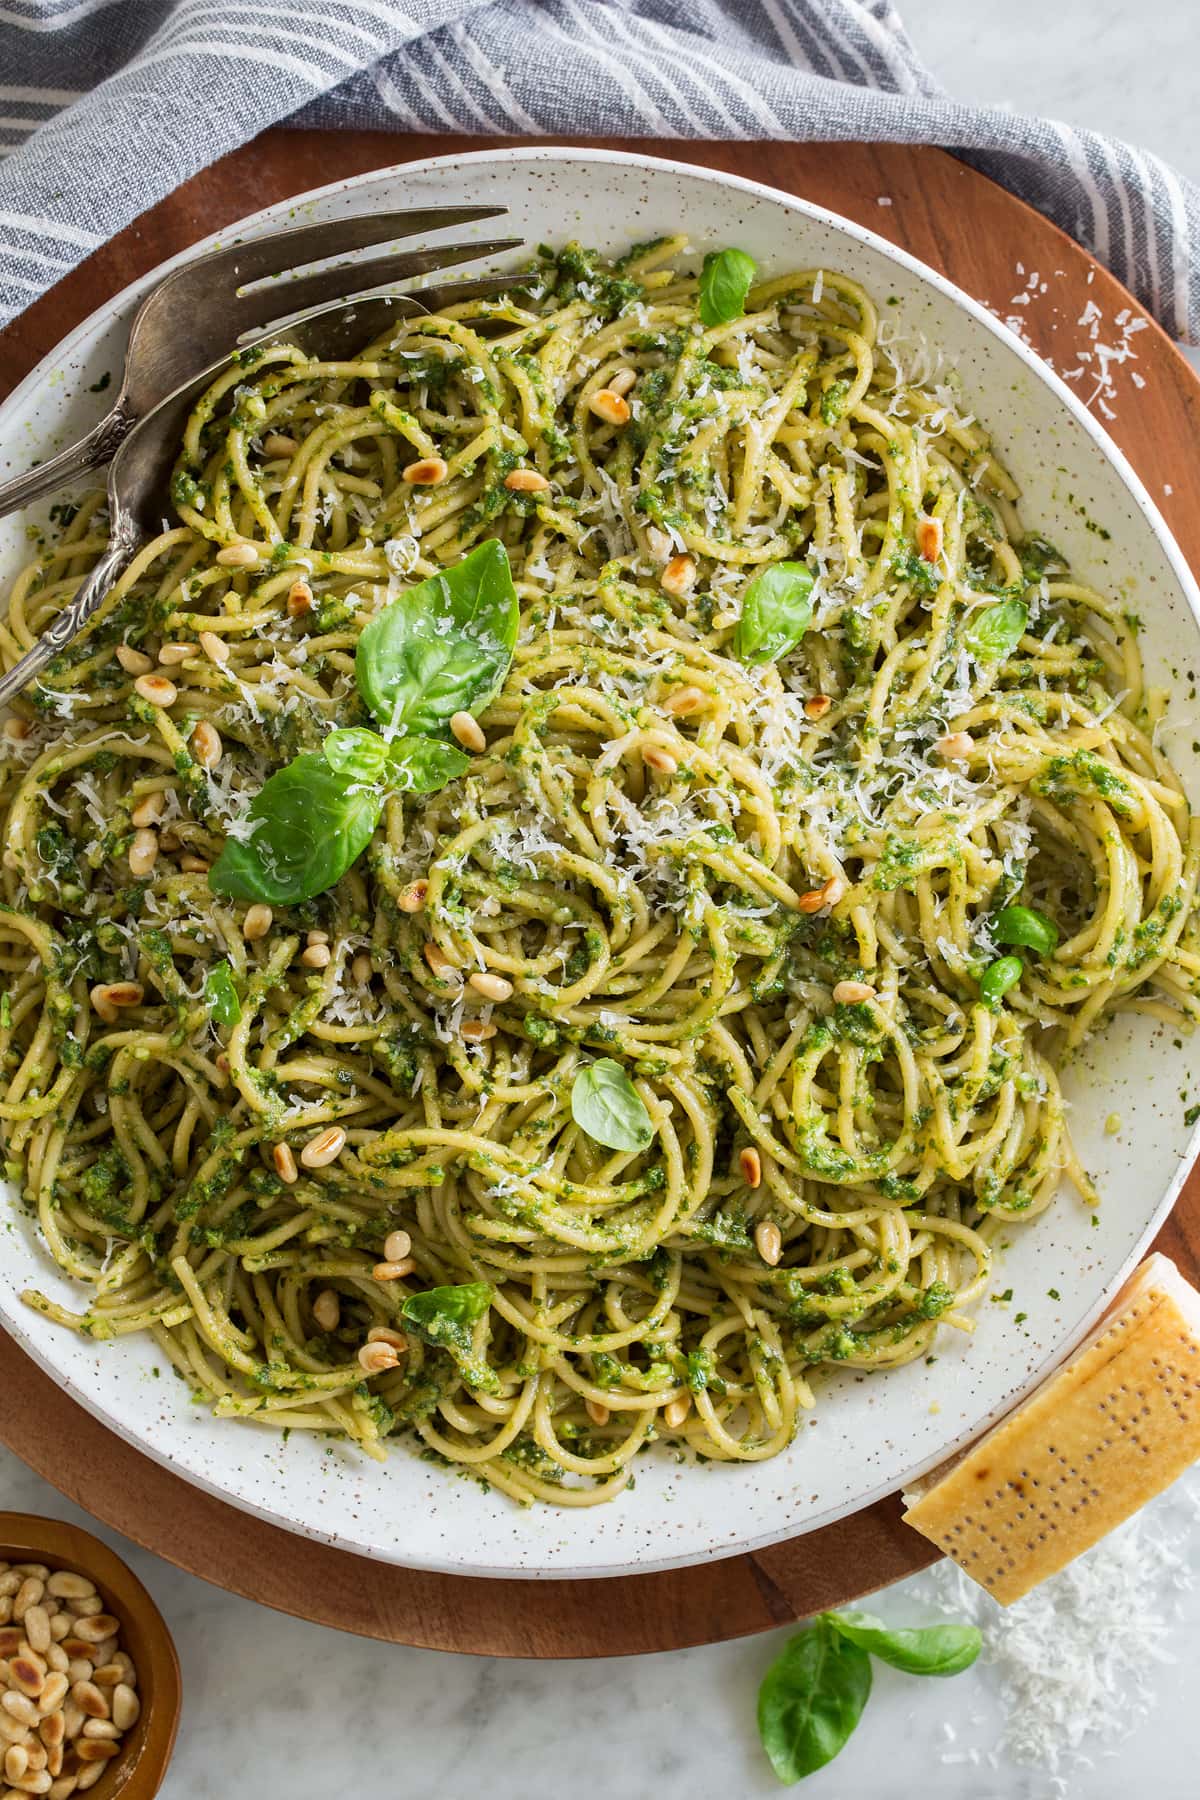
[0,1512,182,1800]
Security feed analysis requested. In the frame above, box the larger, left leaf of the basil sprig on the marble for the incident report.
[757,1616,871,1782]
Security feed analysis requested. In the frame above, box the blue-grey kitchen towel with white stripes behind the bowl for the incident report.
[0,0,1200,342]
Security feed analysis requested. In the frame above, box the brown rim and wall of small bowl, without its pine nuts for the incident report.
[0,1512,182,1800]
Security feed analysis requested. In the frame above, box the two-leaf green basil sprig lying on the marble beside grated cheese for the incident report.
[757,1613,982,1784]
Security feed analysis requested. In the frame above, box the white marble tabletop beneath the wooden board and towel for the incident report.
[0,0,1200,1800]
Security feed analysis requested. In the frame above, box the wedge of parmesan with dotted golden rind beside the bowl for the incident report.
[905,1255,1200,1606]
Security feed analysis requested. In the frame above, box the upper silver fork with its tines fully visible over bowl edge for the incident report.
[0,207,522,518]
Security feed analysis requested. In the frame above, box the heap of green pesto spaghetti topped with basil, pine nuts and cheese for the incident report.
[0,238,1200,1505]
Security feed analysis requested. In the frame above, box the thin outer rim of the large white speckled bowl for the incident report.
[0,144,1200,1580]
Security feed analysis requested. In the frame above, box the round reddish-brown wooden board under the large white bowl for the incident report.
[0,130,1200,1656]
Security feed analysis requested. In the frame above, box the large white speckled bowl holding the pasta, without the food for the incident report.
[0,149,1200,1575]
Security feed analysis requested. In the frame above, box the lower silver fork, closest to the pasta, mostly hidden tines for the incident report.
[0,270,520,706]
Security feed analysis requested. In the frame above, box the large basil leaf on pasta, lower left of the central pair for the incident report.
[209,752,383,905]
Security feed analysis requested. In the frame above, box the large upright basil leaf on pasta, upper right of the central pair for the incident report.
[354,538,518,736]
